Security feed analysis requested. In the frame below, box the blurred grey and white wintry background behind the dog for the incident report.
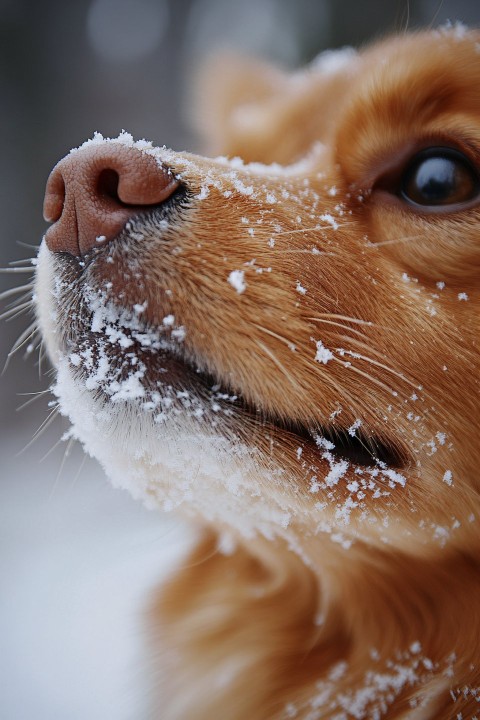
[0,0,480,720]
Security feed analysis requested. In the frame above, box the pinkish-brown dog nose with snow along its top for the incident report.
[43,143,178,256]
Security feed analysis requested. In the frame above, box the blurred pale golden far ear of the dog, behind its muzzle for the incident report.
[189,52,289,161]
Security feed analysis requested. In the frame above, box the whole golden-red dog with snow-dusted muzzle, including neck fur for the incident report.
[30,25,480,720]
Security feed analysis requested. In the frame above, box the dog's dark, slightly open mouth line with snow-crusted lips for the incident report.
[51,268,408,470]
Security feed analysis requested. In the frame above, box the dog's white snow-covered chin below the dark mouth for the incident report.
[53,357,302,537]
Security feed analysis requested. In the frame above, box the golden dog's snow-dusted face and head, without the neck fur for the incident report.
[36,26,480,554]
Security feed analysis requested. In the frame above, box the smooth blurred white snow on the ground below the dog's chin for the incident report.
[0,426,188,720]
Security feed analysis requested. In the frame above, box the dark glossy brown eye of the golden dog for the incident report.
[400,147,480,207]
